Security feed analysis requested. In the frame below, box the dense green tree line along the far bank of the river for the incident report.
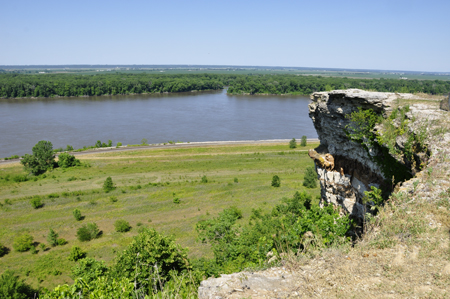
[0,73,450,98]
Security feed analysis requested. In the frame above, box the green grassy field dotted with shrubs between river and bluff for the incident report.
[0,144,320,288]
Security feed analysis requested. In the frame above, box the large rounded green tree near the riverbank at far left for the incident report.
[20,140,55,175]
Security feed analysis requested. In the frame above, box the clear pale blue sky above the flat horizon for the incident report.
[0,0,450,72]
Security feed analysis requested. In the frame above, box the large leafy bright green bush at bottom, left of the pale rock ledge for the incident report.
[111,228,190,289]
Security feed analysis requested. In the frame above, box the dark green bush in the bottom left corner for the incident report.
[0,270,36,299]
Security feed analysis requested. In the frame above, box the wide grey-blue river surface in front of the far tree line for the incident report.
[0,90,317,157]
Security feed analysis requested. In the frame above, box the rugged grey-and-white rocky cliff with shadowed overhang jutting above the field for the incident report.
[309,89,433,217]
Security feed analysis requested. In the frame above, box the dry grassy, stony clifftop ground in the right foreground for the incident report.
[199,104,450,299]
